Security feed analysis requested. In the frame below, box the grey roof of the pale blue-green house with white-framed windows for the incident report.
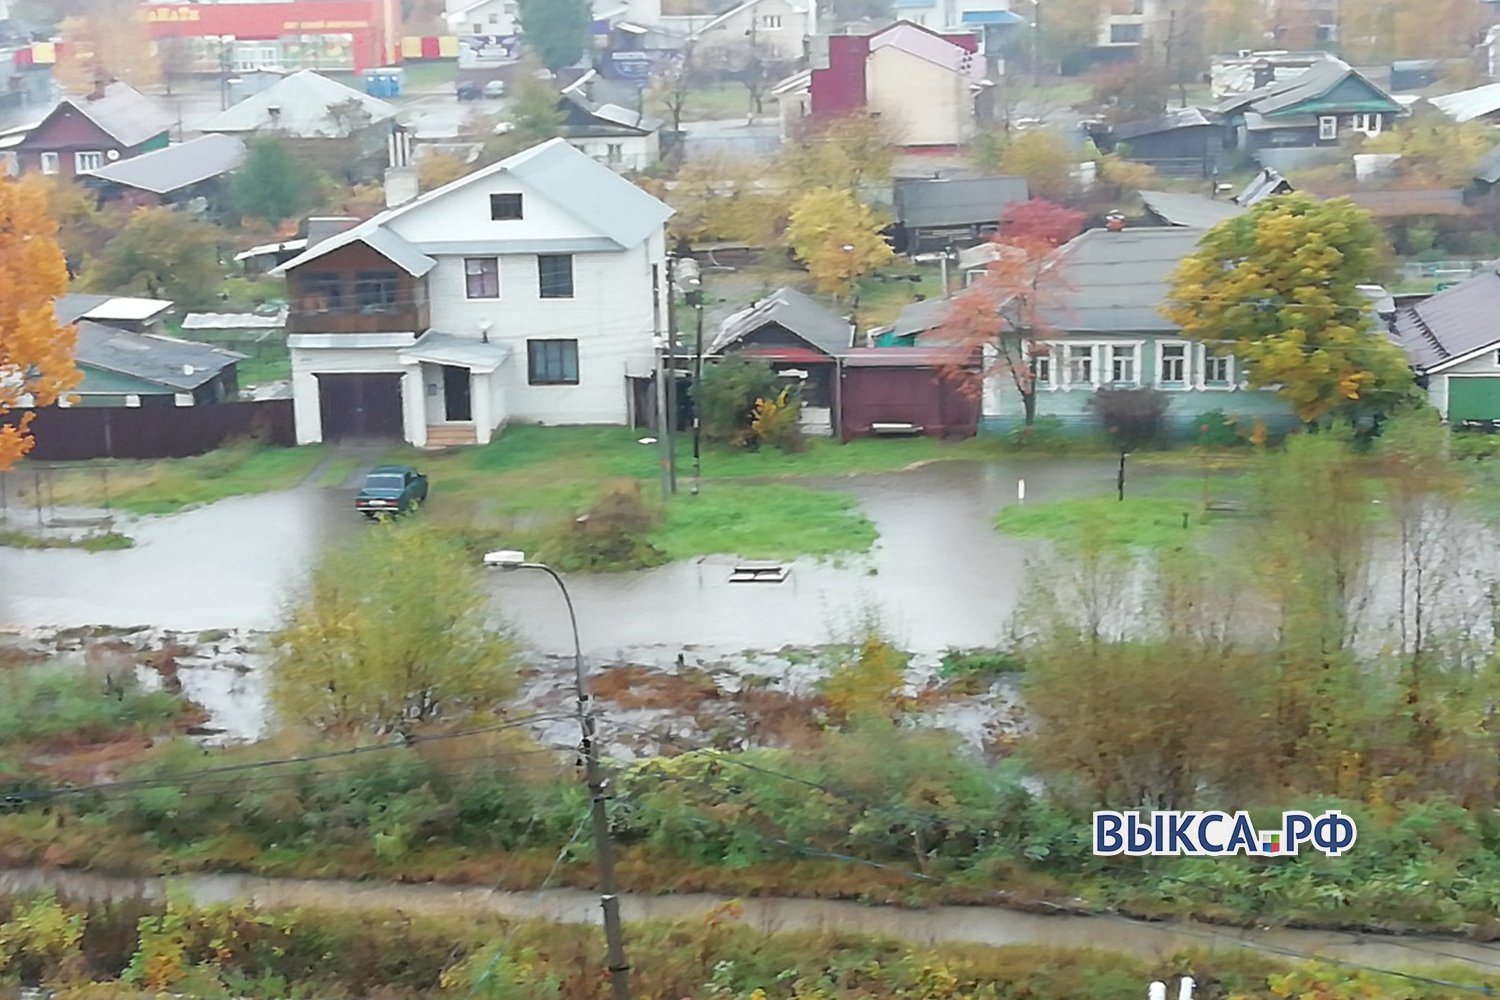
[1038,228,1203,333]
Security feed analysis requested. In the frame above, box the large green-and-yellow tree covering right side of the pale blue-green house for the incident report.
[1163,193,1415,424]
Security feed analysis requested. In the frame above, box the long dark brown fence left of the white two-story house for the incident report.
[5,399,297,462]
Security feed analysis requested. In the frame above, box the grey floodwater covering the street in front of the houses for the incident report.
[0,459,1149,660]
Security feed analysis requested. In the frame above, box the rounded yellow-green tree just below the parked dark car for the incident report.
[270,525,518,736]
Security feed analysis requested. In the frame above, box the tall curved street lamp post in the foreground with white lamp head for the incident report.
[485,549,630,1000]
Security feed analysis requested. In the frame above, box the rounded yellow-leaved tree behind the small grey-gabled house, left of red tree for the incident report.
[786,187,896,297]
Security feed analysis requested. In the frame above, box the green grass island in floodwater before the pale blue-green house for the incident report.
[995,496,1206,549]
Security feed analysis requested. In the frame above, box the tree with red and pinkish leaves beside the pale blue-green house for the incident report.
[938,198,1083,426]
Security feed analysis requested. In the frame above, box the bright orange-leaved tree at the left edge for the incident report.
[0,180,83,469]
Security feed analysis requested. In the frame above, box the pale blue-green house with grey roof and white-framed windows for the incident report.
[896,228,1296,435]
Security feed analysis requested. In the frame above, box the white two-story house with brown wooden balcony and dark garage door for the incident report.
[276,139,672,447]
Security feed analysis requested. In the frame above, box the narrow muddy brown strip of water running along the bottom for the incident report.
[0,868,1500,972]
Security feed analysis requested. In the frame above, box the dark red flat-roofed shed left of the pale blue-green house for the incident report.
[840,348,981,441]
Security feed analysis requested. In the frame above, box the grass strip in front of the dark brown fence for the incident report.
[21,444,326,514]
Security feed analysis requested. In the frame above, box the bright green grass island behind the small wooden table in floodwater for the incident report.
[651,484,876,559]
